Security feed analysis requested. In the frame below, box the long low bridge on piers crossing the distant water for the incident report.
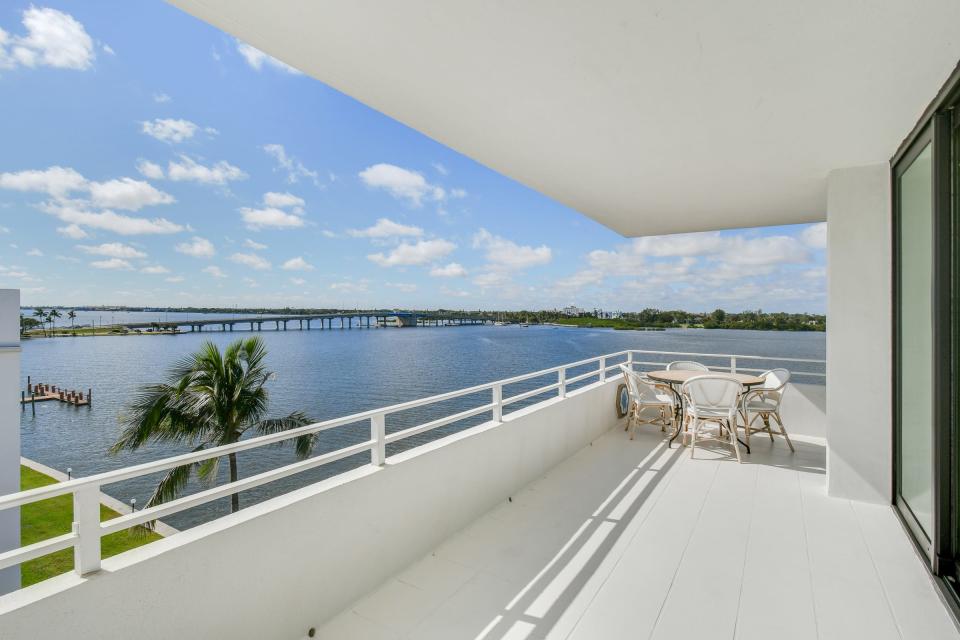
[109,310,492,333]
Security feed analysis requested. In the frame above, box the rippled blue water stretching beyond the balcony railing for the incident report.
[21,312,825,528]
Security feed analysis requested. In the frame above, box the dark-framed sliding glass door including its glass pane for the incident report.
[892,68,960,615]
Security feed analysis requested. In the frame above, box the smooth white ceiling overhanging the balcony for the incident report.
[171,0,960,236]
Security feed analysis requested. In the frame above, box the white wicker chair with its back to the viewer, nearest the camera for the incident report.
[681,374,743,462]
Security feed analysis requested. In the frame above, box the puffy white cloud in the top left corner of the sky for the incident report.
[0,6,96,71]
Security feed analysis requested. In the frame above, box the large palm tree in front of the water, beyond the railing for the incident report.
[110,337,317,511]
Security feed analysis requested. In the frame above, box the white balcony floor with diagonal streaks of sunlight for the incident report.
[317,425,960,640]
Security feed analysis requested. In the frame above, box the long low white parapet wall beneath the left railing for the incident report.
[0,376,619,640]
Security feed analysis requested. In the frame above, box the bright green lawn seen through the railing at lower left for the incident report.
[20,465,161,587]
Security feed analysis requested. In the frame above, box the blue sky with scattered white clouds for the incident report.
[0,1,826,312]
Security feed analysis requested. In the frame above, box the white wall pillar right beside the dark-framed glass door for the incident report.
[827,163,892,503]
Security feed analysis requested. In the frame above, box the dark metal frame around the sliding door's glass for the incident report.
[890,65,960,619]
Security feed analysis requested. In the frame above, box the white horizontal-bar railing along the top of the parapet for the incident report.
[0,350,825,575]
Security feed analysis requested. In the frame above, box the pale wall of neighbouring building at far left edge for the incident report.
[0,289,20,593]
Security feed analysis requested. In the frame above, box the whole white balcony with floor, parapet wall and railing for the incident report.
[0,351,957,638]
